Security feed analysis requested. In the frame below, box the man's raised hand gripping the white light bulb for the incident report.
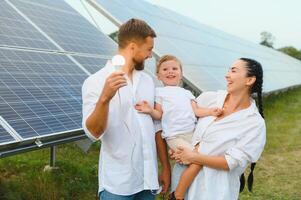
[101,71,127,102]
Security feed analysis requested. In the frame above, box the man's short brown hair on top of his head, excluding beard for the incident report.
[118,18,156,48]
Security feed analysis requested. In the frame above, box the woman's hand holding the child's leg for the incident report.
[169,147,198,165]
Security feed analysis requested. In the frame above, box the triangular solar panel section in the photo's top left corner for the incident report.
[0,1,57,50]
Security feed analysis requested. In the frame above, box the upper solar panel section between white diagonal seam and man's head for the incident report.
[10,0,116,55]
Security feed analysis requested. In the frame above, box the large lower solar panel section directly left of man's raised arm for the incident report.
[0,48,87,139]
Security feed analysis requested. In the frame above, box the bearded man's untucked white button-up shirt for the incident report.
[82,61,159,195]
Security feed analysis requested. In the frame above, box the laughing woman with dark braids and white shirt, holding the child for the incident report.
[171,58,266,200]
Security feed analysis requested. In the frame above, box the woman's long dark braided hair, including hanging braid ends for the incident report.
[239,58,264,192]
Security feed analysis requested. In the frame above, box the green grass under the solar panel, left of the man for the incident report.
[0,144,99,200]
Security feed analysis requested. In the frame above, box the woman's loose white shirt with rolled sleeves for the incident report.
[188,91,266,200]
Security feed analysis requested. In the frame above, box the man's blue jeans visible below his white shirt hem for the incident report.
[99,190,156,200]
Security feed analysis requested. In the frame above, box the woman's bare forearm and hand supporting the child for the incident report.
[171,147,229,171]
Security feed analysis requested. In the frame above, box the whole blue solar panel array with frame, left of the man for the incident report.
[0,0,122,154]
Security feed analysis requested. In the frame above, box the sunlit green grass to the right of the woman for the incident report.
[240,87,301,200]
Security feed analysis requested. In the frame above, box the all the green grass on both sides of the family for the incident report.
[0,88,301,200]
